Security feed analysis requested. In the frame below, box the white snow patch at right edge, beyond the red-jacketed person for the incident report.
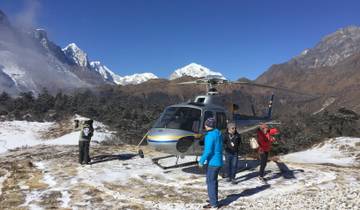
[281,137,360,167]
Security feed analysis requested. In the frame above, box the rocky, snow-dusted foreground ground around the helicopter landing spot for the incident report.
[0,145,360,209]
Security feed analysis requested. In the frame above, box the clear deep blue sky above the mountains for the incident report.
[0,0,360,80]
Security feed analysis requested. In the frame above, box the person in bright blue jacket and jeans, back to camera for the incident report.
[199,118,223,208]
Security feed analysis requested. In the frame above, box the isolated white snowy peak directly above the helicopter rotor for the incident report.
[170,63,224,80]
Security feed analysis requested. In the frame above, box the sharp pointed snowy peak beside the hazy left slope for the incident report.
[63,43,89,67]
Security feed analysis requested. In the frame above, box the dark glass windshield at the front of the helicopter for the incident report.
[154,107,201,133]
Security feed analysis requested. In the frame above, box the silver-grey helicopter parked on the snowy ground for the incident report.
[138,76,295,168]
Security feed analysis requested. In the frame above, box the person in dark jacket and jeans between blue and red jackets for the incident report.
[224,123,241,184]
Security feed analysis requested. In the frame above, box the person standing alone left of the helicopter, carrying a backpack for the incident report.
[79,120,94,164]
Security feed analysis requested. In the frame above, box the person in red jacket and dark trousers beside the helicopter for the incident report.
[257,123,279,182]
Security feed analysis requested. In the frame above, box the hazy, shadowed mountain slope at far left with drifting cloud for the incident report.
[0,8,98,95]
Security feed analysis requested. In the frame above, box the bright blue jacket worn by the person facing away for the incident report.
[199,129,223,167]
